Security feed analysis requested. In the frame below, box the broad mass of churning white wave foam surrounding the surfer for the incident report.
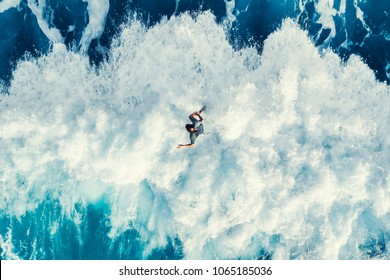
[0,13,390,259]
